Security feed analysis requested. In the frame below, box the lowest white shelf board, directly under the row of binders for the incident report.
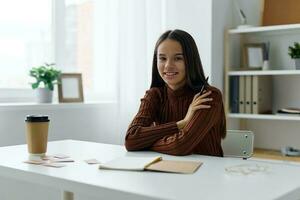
[227,113,300,121]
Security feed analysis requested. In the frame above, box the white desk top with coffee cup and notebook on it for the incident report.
[0,140,300,200]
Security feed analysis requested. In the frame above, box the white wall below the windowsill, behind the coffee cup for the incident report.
[0,103,119,146]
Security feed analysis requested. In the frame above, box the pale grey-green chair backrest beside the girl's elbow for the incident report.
[222,130,254,159]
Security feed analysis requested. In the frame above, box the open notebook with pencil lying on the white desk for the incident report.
[99,156,202,174]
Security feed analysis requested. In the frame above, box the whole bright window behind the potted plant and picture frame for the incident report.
[0,0,106,102]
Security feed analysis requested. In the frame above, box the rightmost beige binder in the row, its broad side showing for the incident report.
[252,76,272,114]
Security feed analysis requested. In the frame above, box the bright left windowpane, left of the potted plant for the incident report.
[0,0,53,89]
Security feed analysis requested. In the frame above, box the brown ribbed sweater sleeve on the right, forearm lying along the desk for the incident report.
[151,89,224,155]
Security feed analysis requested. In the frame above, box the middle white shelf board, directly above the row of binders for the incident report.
[228,70,300,76]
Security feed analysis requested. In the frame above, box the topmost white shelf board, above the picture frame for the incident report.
[228,24,300,34]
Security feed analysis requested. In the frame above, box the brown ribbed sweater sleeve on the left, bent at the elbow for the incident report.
[125,88,178,151]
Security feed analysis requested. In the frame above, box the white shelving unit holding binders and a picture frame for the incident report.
[225,24,300,122]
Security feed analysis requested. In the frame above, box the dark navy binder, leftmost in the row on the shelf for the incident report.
[229,76,240,113]
